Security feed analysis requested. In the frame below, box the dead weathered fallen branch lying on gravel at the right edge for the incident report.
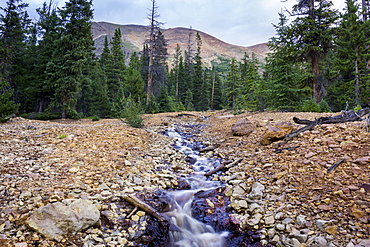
[284,107,370,142]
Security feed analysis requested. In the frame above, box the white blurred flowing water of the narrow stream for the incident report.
[166,128,228,247]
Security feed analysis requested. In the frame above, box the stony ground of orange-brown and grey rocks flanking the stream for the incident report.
[0,111,370,247]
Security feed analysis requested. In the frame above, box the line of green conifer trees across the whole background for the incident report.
[0,0,370,125]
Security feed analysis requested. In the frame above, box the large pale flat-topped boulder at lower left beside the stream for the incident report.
[26,199,100,241]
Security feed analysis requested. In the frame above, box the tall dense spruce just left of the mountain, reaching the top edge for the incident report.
[49,0,94,118]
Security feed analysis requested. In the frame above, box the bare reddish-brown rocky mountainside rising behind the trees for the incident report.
[92,22,269,65]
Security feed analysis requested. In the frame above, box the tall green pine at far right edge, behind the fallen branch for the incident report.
[329,0,370,109]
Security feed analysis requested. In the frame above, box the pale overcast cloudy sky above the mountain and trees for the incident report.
[0,0,345,46]
